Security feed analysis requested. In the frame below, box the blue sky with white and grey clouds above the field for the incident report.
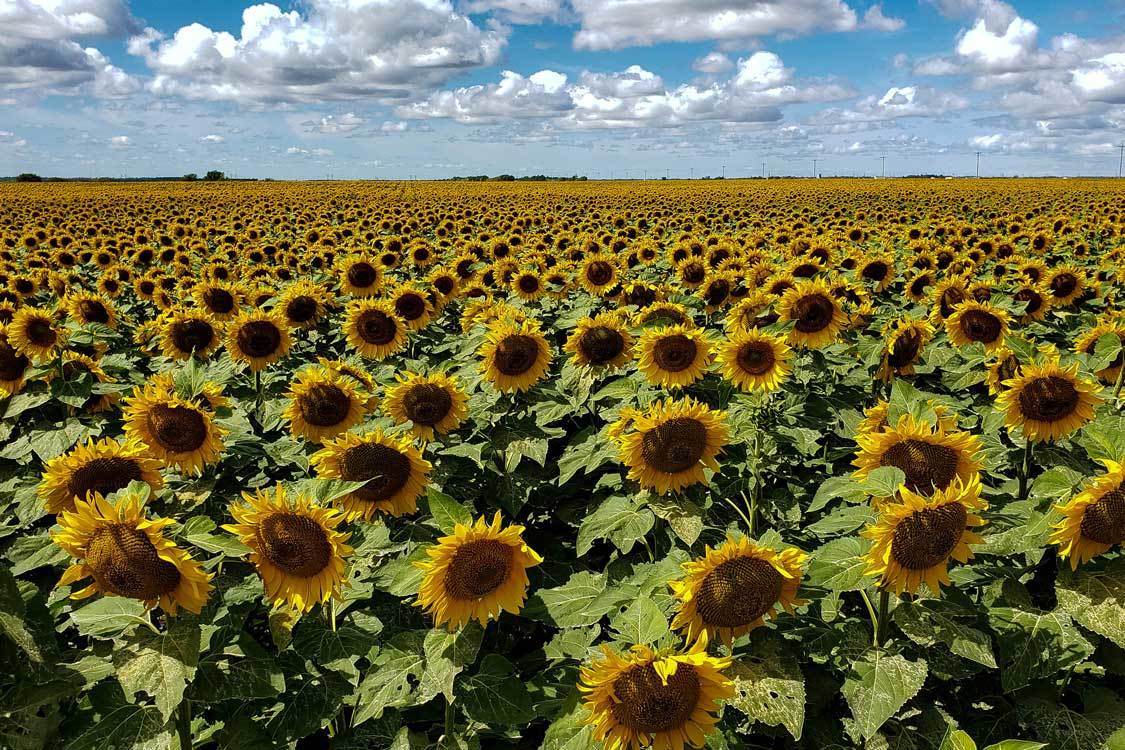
[0,0,1125,179]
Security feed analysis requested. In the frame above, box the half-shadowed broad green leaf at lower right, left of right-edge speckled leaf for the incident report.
[989,607,1094,693]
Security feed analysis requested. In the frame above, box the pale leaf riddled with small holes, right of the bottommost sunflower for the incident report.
[727,633,804,740]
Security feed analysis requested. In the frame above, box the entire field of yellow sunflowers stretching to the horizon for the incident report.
[0,180,1125,750]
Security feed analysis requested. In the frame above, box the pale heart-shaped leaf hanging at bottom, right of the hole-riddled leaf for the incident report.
[843,651,927,739]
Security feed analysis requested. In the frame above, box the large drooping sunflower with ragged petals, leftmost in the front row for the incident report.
[51,493,212,615]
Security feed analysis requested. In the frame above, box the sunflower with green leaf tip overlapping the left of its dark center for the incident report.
[311,430,431,521]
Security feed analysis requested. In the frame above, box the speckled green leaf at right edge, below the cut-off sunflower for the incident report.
[1055,558,1125,649]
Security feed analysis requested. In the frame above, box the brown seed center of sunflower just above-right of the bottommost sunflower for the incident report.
[695,558,783,627]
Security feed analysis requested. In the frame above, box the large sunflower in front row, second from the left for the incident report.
[223,485,352,614]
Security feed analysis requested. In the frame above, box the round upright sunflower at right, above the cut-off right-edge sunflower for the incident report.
[996,358,1101,443]
